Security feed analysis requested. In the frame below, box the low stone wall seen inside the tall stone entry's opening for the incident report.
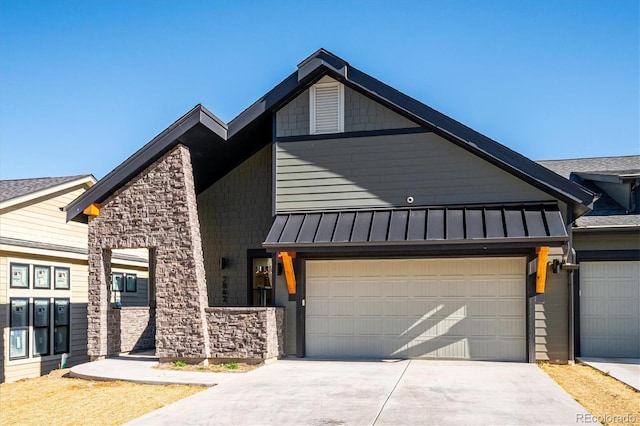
[108,307,156,354]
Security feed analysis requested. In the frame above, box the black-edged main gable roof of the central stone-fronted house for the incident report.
[67,49,594,221]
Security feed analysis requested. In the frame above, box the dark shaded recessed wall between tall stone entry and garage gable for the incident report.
[198,144,272,306]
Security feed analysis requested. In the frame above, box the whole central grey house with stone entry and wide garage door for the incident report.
[66,49,595,362]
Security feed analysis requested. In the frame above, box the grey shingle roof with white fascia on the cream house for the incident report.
[0,175,96,208]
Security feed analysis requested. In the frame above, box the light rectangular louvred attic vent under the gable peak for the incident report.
[309,82,344,134]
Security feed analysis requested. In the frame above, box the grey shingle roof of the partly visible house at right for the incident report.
[538,155,640,232]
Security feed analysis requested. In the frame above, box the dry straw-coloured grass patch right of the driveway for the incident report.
[539,363,640,426]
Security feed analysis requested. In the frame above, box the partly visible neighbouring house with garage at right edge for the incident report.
[539,155,640,358]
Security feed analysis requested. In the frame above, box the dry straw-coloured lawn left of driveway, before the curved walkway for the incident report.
[0,370,207,426]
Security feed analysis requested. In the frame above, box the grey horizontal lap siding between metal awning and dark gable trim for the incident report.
[276,133,550,212]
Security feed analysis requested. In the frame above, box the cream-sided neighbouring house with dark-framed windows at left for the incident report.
[0,175,147,382]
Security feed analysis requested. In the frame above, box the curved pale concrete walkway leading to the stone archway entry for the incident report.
[69,356,242,386]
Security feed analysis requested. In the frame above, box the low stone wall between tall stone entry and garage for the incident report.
[206,307,284,361]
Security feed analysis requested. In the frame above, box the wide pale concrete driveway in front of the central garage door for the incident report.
[130,359,587,425]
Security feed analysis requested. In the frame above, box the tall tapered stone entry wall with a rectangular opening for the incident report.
[87,145,211,359]
